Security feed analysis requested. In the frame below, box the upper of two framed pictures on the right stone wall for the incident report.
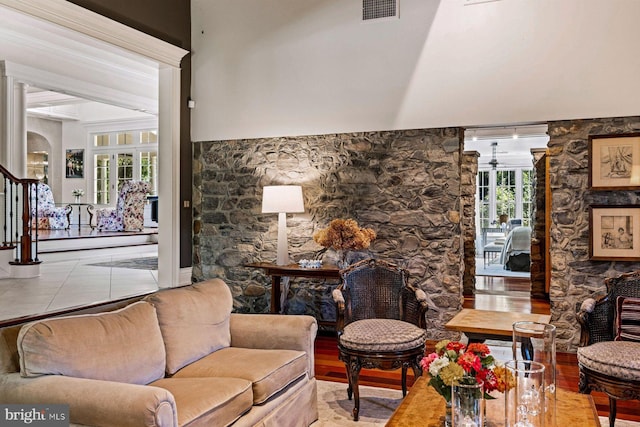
[589,133,640,190]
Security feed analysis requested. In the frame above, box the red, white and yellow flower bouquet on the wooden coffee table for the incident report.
[420,340,514,403]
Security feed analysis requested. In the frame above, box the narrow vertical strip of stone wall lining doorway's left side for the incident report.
[461,151,480,295]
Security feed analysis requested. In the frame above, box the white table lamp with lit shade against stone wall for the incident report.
[262,185,304,265]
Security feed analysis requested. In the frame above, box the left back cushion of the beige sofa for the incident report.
[17,301,165,384]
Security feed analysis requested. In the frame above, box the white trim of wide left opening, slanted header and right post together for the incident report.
[0,0,188,287]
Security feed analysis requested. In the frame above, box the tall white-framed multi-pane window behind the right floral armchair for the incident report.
[91,129,158,204]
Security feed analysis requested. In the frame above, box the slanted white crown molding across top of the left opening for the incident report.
[0,0,189,68]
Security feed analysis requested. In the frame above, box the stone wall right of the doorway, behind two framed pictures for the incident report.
[548,117,640,351]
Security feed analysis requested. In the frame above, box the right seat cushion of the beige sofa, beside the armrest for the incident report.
[174,347,307,404]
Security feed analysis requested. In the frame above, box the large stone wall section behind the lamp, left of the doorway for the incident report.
[193,128,464,339]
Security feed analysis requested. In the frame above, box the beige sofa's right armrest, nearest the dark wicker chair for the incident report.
[230,313,318,378]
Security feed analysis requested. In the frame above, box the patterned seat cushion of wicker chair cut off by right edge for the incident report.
[578,341,640,381]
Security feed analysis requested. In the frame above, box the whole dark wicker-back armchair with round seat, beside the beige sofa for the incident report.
[333,259,427,421]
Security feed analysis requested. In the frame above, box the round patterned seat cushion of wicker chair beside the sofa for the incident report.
[340,319,427,352]
